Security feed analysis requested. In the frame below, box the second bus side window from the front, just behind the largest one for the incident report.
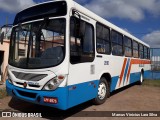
[96,23,111,54]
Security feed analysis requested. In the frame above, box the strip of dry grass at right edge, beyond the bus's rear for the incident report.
[143,80,160,87]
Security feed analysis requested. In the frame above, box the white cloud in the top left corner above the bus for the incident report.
[0,0,35,12]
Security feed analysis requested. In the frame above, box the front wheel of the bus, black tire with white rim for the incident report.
[93,77,110,105]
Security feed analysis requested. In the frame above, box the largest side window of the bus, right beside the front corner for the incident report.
[70,17,95,64]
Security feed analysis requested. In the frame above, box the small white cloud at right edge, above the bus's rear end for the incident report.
[142,30,160,48]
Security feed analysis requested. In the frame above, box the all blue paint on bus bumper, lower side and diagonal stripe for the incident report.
[6,70,149,110]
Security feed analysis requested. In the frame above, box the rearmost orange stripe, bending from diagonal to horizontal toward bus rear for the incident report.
[127,59,151,82]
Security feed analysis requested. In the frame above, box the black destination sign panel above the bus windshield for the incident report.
[13,1,67,25]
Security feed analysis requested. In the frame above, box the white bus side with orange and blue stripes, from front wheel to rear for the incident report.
[95,54,151,92]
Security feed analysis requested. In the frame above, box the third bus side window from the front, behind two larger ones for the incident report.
[111,31,123,56]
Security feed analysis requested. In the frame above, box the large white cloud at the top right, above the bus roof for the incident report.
[83,0,160,21]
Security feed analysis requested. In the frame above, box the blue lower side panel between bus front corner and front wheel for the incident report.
[68,79,99,108]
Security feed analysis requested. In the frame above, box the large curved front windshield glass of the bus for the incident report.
[9,19,66,69]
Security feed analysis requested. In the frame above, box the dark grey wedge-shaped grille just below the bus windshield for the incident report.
[12,71,47,81]
